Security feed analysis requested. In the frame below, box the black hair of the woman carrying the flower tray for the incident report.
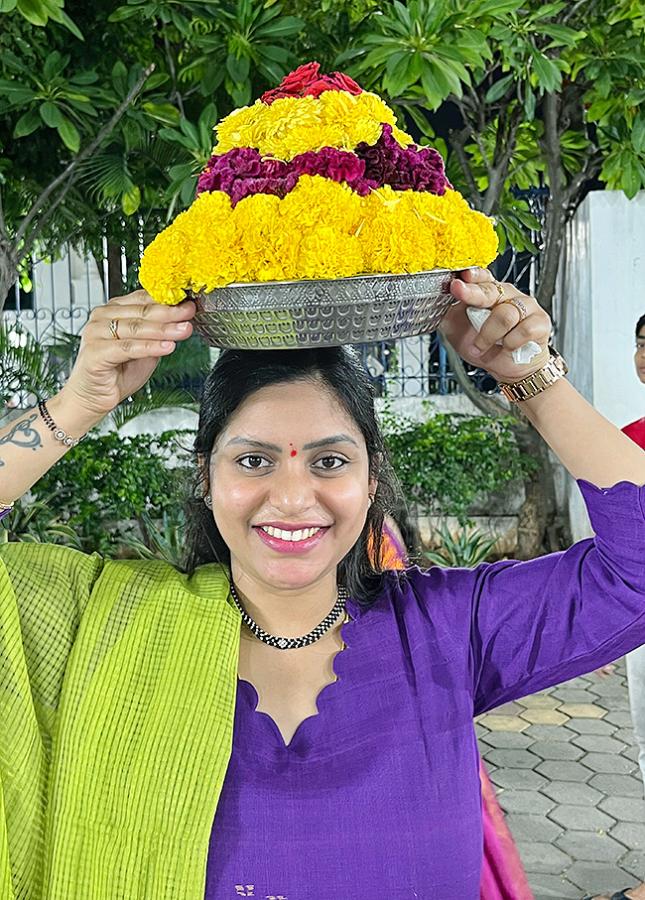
[183,347,412,606]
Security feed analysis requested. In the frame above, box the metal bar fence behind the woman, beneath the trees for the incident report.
[4,188,548,398]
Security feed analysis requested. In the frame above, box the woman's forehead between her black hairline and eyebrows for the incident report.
[218,381,364,445]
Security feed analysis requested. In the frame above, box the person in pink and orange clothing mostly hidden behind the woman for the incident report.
[369,506,534,900]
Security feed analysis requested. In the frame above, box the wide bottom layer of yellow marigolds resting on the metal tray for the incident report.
[140,181,497,304]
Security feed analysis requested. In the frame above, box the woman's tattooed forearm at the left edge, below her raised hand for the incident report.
[0,389,101,504]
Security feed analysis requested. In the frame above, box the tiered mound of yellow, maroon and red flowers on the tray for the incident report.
[139,63,497,304]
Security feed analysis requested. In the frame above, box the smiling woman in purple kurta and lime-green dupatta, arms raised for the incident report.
[0,271,645,900]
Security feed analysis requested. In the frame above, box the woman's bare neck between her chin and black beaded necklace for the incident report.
[231,564,342,637]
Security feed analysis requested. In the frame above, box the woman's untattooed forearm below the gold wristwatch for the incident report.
[520,378,645,487]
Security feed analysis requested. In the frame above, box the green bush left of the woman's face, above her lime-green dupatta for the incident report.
[25,430,192,557]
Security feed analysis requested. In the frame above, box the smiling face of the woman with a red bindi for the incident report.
[210,382,377,589]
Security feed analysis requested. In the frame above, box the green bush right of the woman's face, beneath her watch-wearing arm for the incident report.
[382,403,535,525]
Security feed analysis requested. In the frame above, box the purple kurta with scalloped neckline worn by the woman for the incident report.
[206,481,645,900]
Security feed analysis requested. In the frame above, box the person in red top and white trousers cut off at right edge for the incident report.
[586,314,645,900]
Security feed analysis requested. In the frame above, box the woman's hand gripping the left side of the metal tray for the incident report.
[62,291,197,417]
